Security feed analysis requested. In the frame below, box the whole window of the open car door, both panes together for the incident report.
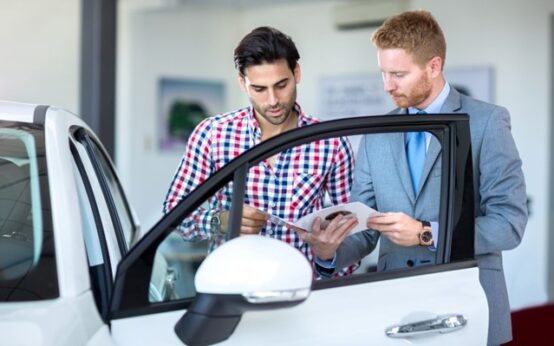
[146,132,441,302]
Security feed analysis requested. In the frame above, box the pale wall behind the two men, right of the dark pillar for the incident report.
[117,0,554,309]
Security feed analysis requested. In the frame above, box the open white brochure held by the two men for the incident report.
[264,202,381,233]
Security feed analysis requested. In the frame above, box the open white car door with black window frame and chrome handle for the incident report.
[111,115,478,345]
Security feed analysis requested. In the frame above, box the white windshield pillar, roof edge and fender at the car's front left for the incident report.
[0,102,115,345]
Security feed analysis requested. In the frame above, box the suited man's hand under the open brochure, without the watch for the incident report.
[294,215,358,260]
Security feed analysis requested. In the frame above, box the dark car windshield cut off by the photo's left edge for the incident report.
[0,121,58,301]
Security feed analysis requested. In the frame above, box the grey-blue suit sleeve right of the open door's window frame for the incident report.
[474,107,527,255]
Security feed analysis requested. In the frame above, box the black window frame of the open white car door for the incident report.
[111,114,476,319]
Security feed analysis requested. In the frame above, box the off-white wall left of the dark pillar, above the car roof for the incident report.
[0,0,81,112]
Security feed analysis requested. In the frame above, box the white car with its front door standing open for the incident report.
[0,102,488,346]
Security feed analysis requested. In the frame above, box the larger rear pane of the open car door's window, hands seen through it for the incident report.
[235,133,441,278]
